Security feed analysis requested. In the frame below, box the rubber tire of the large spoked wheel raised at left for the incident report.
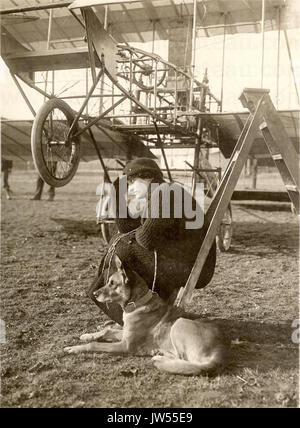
[31,98,80,187]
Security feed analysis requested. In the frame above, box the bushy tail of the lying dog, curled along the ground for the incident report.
[152,356,224,376]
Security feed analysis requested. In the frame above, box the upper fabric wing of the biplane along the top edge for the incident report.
[0,0,300,72]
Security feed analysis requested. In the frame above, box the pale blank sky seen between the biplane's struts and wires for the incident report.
[0,29,300,119]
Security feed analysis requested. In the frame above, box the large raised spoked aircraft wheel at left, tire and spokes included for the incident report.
[31,98,80,187]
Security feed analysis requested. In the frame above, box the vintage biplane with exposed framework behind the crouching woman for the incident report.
[0,0,300,300]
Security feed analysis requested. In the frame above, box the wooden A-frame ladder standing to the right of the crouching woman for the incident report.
[175,89,300,306]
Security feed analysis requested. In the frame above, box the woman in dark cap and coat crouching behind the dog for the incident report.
[89,158,216,324]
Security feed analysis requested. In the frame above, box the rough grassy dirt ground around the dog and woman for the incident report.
[0,171,299,408]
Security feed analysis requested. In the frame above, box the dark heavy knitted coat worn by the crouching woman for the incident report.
[91,182,216,299]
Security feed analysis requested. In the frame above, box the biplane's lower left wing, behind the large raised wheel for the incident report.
[1,119,155,162]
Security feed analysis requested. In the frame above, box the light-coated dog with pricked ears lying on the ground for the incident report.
[64,255,230,375]
